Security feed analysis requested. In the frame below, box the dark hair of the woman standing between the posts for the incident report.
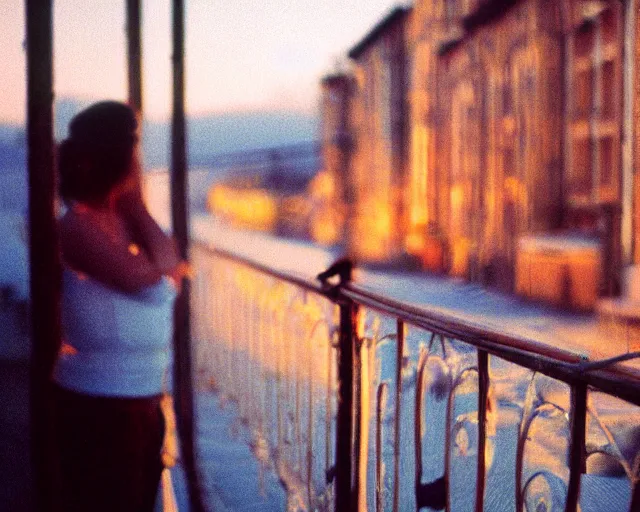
[58,101,138,202]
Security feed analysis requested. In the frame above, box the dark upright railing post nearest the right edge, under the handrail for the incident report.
[565,383,587,512]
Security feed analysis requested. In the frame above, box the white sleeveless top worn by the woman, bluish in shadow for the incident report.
[53,269,176,397]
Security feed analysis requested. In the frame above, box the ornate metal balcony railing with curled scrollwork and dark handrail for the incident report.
[192,243,640,511]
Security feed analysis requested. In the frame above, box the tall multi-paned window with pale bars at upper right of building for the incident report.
[566,1,623,204]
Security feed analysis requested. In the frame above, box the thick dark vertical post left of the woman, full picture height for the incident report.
[25,0,60,510]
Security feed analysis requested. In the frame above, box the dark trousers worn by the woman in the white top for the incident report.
[56,388,164,512]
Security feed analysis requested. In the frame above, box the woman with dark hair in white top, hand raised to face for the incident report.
[54,102,182,511]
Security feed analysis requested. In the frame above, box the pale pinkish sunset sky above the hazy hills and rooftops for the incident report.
[0,0,398,123]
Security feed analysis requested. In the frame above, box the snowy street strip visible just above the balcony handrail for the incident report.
[184,214,640,371]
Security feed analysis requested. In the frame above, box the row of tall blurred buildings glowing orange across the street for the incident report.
[320,0,640,304]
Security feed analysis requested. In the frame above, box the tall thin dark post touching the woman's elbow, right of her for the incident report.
[171,0,204,511]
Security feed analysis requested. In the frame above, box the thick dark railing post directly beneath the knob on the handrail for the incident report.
[335,300,358,512]
